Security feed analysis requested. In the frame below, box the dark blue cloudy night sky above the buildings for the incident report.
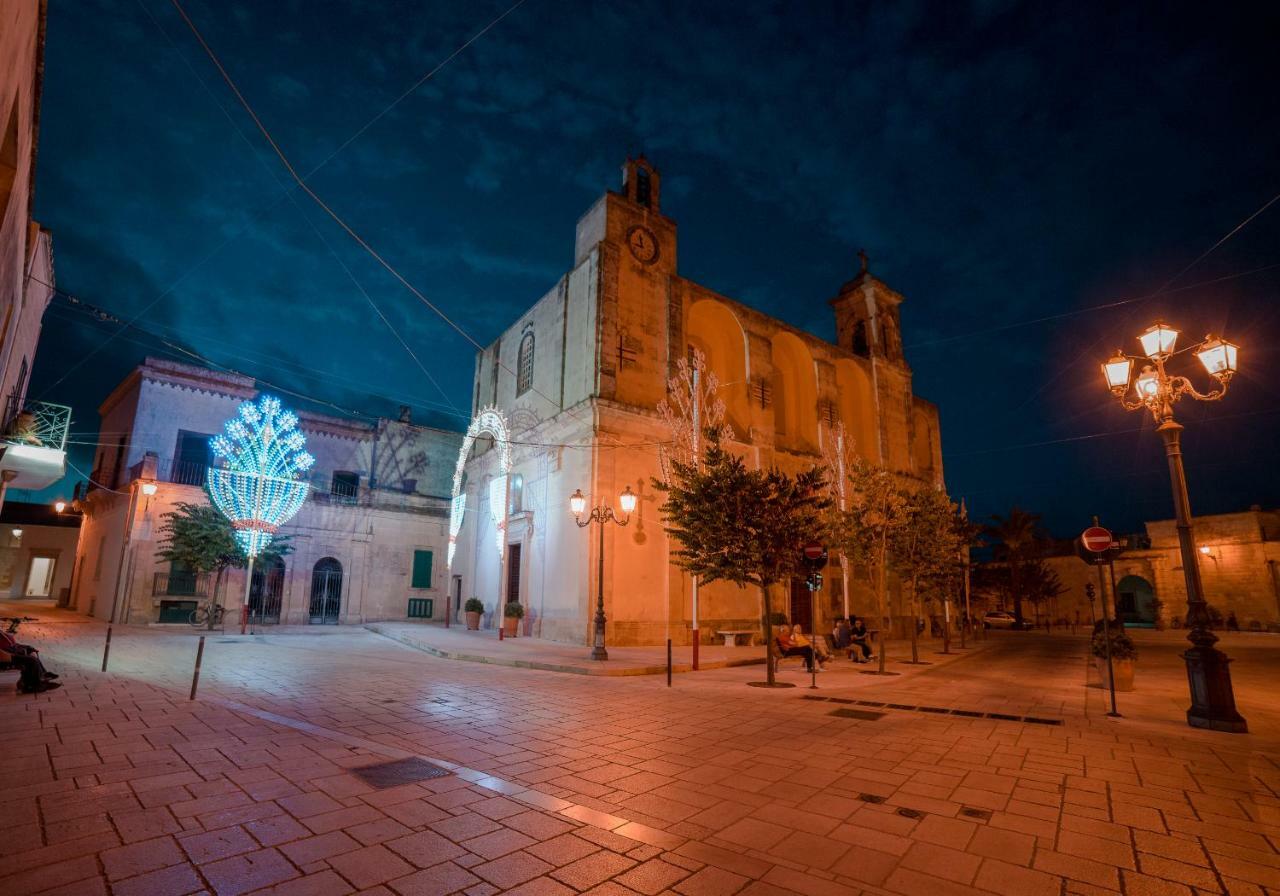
[18,0,1280,535]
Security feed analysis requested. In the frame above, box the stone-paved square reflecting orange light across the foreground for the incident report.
[0,617,1280,896]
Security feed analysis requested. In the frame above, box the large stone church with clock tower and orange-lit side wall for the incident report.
[449,157,942,645]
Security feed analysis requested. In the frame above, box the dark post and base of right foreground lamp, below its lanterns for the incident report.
[1156,416,1249,733]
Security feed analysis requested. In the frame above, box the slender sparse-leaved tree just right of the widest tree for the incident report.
[828,456,905,675]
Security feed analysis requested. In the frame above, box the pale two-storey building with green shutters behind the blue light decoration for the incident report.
[70,358,462,625]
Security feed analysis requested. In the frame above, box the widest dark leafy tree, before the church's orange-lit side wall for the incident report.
[654,430,829,686]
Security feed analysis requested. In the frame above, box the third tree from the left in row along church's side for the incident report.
[888,486,964,663]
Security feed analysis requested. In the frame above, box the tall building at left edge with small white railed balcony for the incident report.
[0,0,70,503]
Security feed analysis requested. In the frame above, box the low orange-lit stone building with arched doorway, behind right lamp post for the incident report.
[1024,507,1280,631]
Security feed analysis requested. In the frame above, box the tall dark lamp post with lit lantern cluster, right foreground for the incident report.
[1102,323,1249,733]
